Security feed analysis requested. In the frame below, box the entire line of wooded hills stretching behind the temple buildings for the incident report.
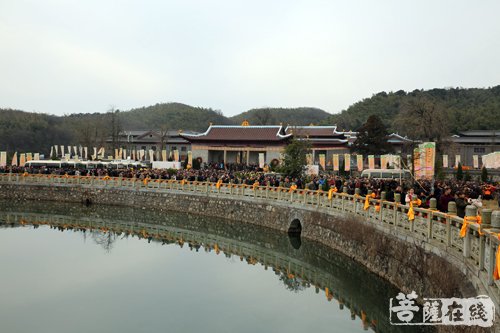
[0,85,500,154]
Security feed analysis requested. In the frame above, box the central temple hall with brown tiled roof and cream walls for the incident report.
[180,122,292,165]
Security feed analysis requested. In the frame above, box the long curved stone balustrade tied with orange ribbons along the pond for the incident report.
[0,174,500,318]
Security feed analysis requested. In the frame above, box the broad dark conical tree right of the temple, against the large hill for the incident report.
[352,115,392,155]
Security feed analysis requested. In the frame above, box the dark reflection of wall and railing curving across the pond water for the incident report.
[0,211,398,332]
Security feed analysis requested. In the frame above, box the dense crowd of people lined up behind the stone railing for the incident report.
[0,163,500,216]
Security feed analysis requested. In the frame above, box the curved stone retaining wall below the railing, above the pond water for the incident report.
[0,180,482,297]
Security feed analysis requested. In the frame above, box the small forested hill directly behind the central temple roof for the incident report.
[230,107,331,126]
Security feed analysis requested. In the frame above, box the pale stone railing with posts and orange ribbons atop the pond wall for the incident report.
[0,173,500,310]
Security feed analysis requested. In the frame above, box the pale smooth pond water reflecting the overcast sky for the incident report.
[0,226,370,333]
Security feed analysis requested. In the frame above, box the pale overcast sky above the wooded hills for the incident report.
[0,0,500,116]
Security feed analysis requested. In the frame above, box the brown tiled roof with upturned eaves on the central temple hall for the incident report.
[180,125,291,142]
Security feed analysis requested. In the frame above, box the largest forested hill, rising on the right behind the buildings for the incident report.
[322,86,500,136]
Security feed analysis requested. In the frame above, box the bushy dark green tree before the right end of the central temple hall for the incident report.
[280,139,311,177]
